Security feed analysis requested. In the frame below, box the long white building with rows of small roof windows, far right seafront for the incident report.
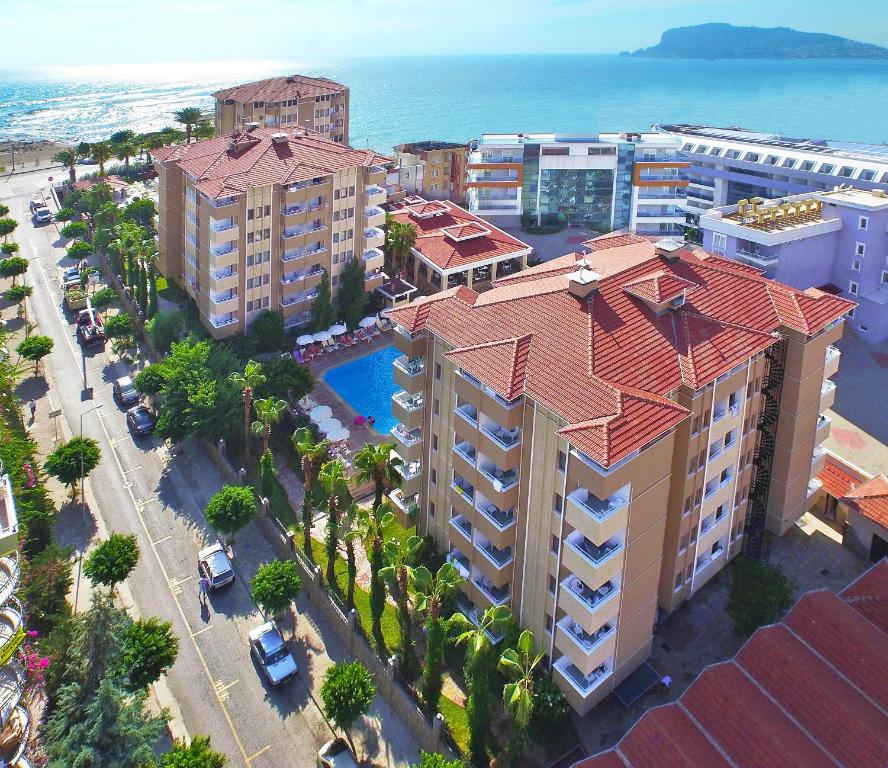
[655,124,888,221]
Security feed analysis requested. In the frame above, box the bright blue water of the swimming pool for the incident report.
[324,345,401,435]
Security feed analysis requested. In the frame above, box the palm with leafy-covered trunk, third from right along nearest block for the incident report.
[410,563,462,715]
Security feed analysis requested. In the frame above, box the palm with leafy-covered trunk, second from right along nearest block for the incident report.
[450,605,512,765]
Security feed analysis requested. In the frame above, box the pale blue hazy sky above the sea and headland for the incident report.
[0,0,888,68]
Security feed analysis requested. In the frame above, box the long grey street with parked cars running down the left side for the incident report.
[0,172,416,768]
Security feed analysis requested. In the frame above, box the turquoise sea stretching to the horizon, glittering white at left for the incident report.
[0,55,888,152]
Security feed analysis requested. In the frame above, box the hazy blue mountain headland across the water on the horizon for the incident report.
[621,24,888,59]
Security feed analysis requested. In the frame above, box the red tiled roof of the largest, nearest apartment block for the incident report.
[390,240,852,466]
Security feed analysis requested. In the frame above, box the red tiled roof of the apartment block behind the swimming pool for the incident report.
[151,128,390,198]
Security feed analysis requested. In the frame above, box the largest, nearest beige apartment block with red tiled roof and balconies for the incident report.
[388,234,852,713]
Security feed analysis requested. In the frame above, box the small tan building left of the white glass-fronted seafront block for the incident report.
[393,141,469,203]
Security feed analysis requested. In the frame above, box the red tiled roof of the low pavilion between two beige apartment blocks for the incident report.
[387,197,530,271]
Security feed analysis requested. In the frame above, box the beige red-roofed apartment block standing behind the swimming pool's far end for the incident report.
[151,126,390,338]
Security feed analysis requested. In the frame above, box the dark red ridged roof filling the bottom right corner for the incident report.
[575,561,888,768]
